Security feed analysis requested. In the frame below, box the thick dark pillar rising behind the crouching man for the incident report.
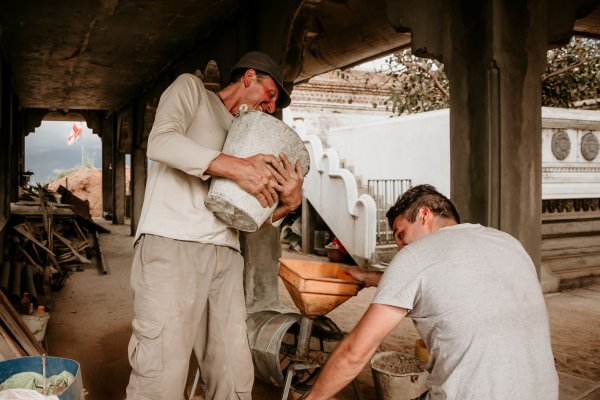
[388,0,552,272]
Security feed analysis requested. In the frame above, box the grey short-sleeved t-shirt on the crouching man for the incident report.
[373,224,558,400]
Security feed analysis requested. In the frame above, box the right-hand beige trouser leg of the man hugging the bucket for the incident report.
[194,246,254,400]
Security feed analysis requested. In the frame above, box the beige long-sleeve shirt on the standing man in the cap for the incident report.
[135,74,239,250]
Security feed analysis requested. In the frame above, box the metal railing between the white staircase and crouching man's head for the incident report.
[367,179,412,244]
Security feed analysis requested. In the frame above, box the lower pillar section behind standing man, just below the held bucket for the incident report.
[240,224,281,312]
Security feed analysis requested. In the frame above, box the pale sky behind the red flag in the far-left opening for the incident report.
[25,121,102,185]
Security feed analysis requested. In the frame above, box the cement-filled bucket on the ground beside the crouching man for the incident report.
[370,351,429,400]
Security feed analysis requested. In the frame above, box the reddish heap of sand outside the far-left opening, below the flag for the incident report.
[48,168,102,217]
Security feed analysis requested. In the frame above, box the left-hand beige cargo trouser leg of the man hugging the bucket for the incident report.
[127,235,215,400]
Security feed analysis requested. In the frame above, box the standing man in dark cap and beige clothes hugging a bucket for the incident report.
[127,52,303,400]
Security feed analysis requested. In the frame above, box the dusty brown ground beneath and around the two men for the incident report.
[47,220,600,400]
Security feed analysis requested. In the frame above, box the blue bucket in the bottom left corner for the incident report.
[0,356,84,400]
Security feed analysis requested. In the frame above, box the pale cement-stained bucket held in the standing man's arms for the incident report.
[205,111,310,232]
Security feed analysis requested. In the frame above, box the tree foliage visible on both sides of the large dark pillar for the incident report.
[339,38,600,115]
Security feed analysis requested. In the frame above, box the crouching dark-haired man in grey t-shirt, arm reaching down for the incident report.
[305,185,558,400]
